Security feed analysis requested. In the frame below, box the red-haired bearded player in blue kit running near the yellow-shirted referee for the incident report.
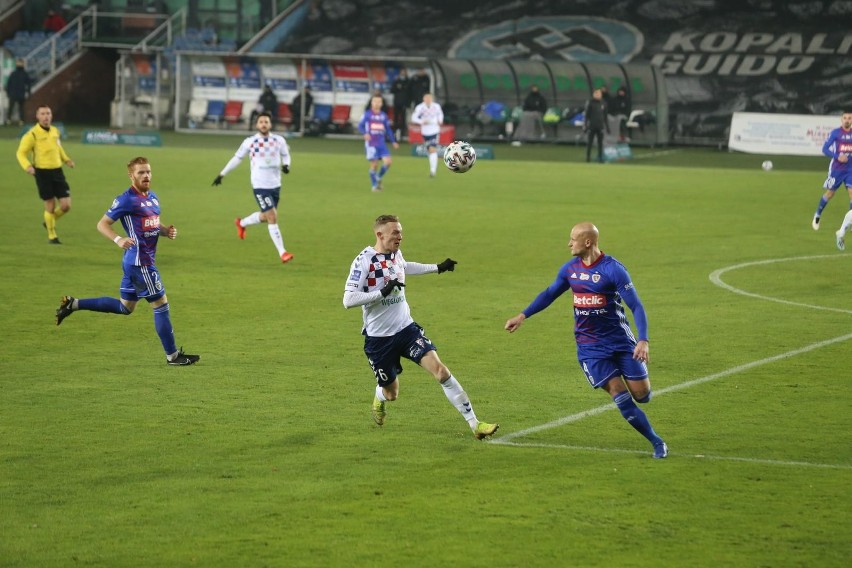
[56,157,201,365]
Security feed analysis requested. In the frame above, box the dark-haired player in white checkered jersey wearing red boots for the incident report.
[213,112,293,262]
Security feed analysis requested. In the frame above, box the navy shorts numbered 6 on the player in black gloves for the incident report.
[364,323,438,387]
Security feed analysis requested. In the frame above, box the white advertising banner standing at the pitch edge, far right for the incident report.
[728,112,840,156]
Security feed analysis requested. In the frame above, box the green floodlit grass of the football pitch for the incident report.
[0,128,852,568]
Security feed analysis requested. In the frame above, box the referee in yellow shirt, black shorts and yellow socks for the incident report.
[17,105,74,245]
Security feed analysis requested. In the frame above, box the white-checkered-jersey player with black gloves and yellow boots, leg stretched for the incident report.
[343,215,499,440]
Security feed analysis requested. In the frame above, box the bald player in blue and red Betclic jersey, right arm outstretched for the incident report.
[505,222,668,458]
